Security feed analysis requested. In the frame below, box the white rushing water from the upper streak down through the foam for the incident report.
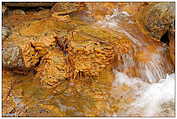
[97,9,175,117]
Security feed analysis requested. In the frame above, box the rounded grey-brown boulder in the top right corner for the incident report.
[143,2,175,40]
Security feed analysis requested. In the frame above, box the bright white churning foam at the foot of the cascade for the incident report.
[113,72,175,116]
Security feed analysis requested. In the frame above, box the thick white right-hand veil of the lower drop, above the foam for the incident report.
[136,46,173,83]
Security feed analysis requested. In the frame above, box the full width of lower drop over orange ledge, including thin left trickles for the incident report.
[116,46,173,83]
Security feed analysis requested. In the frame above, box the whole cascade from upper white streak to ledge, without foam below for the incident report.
[97,9,173,83]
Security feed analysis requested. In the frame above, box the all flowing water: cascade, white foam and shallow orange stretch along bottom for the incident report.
[3,4,175,117]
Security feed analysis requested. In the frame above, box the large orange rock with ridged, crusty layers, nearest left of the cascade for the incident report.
[67,27,115,79]
